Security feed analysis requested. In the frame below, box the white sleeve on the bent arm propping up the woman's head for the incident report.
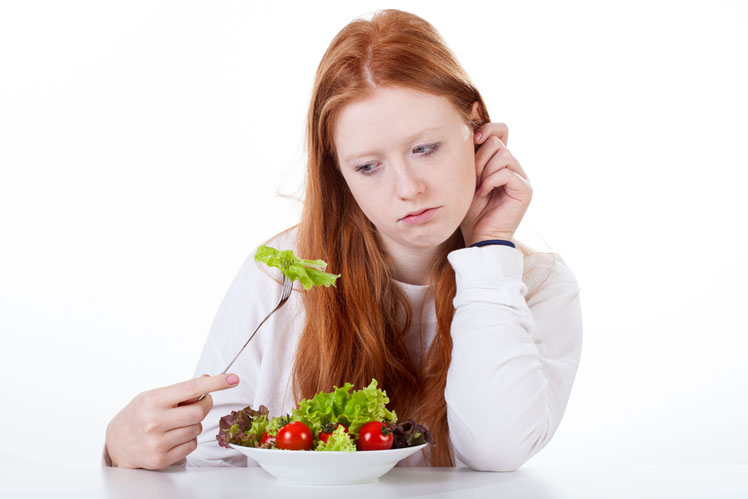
[444,245,582,471]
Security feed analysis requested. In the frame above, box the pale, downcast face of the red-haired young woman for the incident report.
[333,87,476,255]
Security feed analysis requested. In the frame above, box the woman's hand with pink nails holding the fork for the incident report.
[106,374,239,470]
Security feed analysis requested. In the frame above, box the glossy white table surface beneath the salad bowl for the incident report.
[0,464,748,499]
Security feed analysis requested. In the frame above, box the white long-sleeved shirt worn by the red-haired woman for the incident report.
[187,229,582,471]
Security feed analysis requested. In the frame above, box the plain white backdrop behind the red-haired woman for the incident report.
[0,0,748,466]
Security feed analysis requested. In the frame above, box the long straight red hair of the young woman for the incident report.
[293,10,536,466]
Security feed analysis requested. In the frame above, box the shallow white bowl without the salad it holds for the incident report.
[230,444,428,485]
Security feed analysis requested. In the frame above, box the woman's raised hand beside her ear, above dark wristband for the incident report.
[460,123,532,246]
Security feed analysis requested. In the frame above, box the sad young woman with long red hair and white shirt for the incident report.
[105,10,582,471]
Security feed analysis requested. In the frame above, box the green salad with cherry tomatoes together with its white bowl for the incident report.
[216,379,435,485]
